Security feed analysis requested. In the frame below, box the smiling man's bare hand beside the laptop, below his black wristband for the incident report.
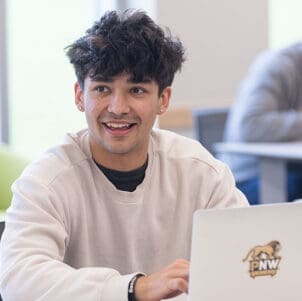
[135,259,189,301]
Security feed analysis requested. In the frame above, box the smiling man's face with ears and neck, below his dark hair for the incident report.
[75,73,171,169]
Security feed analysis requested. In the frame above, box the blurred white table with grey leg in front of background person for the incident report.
[214,142,302,203]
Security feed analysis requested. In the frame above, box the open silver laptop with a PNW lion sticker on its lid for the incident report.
[188,202,302,301]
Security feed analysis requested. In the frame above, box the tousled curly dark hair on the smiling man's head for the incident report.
[66,10,184,94]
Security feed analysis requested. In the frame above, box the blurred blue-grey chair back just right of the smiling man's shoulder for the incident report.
[192,108,229,155]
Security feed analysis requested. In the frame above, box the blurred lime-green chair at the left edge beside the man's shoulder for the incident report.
[0,144,28,217]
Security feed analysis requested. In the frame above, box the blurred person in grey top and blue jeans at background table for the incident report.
[220,43,302,204]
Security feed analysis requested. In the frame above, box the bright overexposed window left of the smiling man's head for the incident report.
[0,0,154,159]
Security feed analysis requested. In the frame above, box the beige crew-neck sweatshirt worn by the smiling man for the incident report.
[0,130,248,301]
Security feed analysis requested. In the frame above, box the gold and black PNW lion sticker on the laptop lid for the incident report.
[242,240,281,278]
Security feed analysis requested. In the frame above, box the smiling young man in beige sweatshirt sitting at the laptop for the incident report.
[0,12,247,301]
